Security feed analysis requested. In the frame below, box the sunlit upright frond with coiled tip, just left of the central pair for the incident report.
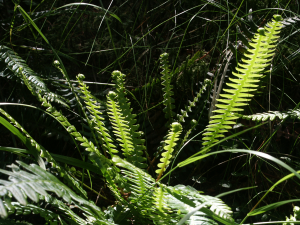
[77,74,118,157]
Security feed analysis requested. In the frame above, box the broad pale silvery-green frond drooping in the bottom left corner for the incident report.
[0,161,108,219]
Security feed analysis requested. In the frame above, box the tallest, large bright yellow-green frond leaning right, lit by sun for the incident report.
[203,15,282,147]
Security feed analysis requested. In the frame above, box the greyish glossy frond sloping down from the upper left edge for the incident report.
[0,45,68,107]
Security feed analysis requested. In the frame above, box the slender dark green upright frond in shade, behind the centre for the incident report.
[160,53,175,123]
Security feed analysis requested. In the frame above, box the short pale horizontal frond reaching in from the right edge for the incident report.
[241,109,300,121]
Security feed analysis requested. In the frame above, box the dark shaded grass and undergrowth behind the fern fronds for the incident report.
[0,0,300,224]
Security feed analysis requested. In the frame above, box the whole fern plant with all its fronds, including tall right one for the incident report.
[0,15,292,225]
